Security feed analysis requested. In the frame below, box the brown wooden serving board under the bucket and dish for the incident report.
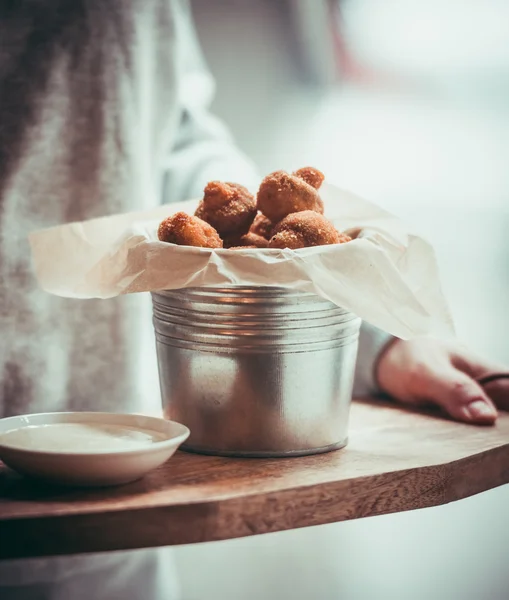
[0,401,509,559]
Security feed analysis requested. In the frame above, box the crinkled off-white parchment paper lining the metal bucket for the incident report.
[30,184,453,339]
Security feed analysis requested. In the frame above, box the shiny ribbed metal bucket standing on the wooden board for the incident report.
[152,287,360,457]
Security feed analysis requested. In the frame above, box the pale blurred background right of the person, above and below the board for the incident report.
[172,0,509,600]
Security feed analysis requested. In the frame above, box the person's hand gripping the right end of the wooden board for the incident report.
[376,339,509,425]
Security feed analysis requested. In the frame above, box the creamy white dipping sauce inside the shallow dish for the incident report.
[0,423,167,454]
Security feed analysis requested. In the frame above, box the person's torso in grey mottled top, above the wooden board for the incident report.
[0,0,179,416]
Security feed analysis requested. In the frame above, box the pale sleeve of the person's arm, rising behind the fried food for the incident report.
[162,0,260,202]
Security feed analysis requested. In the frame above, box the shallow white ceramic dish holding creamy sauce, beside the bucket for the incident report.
[0,412,189,486]
